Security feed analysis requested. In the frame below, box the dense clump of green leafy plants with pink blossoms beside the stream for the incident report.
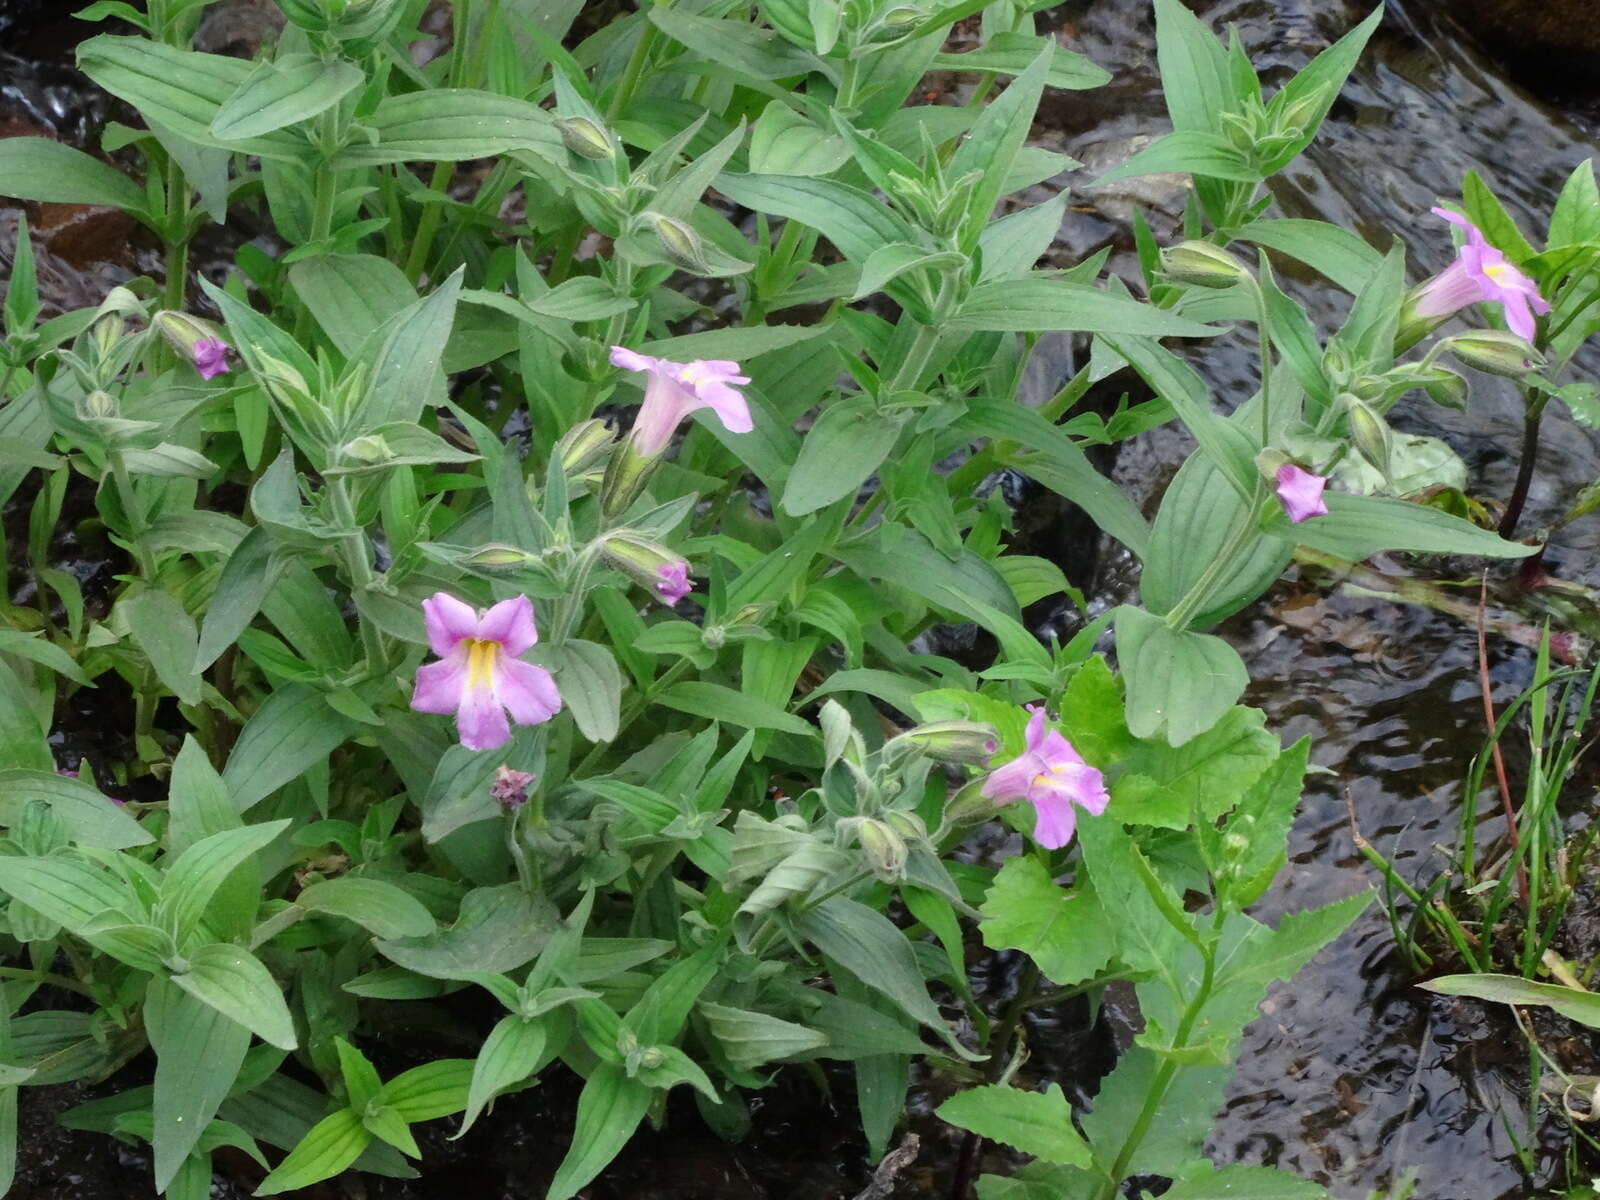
[0,0,1600,1200]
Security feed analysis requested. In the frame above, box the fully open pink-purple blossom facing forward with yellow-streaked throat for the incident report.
[411,592,562,750]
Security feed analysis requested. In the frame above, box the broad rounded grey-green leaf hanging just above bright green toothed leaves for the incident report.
[1115,606,1250,746]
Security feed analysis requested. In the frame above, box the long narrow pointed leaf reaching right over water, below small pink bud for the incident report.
[1267,493,1538,562]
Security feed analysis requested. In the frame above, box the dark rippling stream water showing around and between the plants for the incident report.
[0,0,1600,1200]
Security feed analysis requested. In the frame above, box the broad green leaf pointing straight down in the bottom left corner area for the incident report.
[144,978,250,1190]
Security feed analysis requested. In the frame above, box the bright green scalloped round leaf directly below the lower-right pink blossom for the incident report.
[978,854,1117,987]
